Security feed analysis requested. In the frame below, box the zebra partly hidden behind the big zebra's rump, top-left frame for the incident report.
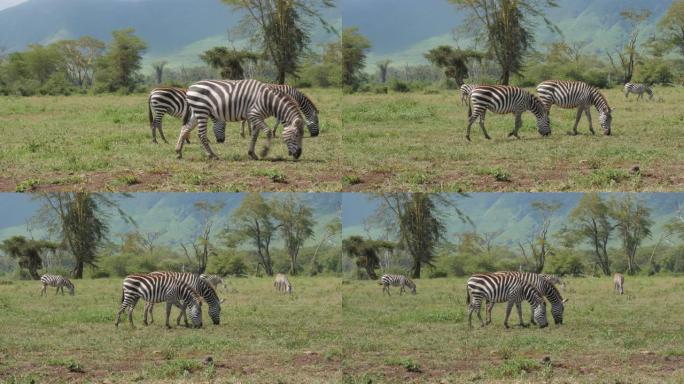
[147,88,226,144]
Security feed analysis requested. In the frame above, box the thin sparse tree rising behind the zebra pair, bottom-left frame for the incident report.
[180,200,225,274]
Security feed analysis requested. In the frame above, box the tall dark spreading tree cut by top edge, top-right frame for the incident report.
[449,0,558,84]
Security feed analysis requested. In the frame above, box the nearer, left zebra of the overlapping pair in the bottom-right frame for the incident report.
[466,273,549,328]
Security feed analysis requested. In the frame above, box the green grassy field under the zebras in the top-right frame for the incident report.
[342,88,684,191]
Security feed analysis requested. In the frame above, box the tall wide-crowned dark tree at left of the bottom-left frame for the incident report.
[35,192,134,279]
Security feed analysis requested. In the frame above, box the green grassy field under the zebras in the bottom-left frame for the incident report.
[0,277,344,383]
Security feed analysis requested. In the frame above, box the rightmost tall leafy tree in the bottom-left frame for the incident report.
[273,195,316,275]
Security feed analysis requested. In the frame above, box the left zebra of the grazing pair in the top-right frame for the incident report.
[466,85,551,141]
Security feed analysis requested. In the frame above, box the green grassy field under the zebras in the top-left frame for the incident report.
[0,89,342,192]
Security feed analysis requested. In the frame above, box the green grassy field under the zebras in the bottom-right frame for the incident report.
[342,276,684,383]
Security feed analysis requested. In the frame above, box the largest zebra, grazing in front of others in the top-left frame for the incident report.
[176,80,304,160]
